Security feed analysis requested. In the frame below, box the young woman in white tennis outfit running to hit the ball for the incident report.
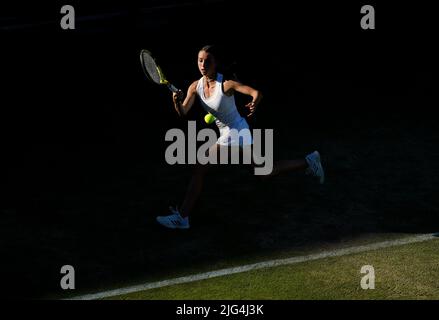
[157,46,324,229]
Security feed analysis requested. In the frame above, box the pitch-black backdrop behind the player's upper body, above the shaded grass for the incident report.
[1,1,436,178]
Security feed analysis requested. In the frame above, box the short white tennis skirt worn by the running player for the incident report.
[216,117,253,147]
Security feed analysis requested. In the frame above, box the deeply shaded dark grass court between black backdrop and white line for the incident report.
[1,112,439,298]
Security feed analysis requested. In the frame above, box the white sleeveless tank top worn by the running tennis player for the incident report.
[197,73,244,128]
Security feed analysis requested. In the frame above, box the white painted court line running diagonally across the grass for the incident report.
[66,233,438,300]
